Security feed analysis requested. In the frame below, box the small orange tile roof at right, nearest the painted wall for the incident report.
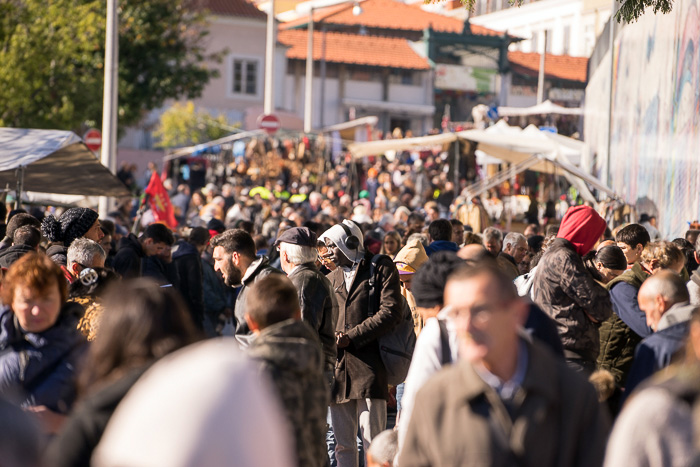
[508,52,588,83]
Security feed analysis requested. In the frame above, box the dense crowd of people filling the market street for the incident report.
[0,154,700,467]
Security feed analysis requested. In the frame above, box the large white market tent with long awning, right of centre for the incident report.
[348,121,619,202]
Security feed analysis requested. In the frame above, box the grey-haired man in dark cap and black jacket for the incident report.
[275,227,338,383]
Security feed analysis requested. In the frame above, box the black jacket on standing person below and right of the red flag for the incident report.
[173,240,204,329]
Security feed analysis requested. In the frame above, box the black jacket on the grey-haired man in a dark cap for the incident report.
[289,263,338,370]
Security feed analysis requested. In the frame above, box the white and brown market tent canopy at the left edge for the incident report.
[0,128,131,202]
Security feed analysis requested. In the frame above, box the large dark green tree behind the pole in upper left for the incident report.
[0,0,220,131]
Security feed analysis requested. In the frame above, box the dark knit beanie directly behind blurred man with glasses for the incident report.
[411,251,464,308]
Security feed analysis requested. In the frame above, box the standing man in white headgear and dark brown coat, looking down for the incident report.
[319,220,403,467]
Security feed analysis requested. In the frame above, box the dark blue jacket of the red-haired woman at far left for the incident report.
[0,308,87,414]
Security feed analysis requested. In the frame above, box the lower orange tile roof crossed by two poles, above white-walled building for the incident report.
[277,30,430,70]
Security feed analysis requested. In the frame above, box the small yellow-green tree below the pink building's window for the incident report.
[154,101,240,148]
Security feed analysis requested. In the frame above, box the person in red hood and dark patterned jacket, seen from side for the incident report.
[532,206,612,374]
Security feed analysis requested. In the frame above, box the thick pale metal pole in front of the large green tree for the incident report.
[99,0,119,217]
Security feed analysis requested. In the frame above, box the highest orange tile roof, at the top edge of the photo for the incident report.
[283,0,503,36]
